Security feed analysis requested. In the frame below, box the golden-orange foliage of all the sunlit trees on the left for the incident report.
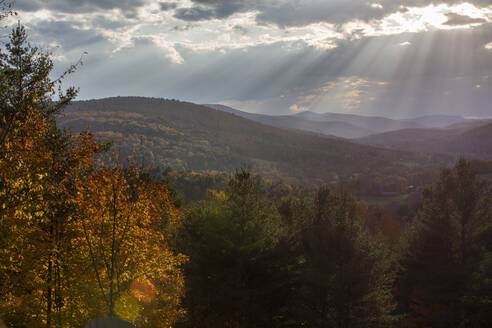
[0,25,183,327]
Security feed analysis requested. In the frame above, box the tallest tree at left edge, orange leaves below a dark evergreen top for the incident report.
[0,25,94,327]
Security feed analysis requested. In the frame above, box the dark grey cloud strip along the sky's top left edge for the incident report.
[14,0,145,14]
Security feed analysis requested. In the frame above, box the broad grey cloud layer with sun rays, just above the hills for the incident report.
[59,26,492,117]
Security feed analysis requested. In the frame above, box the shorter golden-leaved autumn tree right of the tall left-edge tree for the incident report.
[76,165,186,327]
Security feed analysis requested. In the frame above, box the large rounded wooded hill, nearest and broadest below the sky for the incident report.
[58,97,449,184]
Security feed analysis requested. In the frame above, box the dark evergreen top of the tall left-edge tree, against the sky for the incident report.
[0,24,78,153]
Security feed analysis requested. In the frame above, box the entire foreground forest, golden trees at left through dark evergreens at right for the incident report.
[0,18,492,328]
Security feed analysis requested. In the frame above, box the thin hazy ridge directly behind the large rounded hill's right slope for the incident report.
[205,104,374,139]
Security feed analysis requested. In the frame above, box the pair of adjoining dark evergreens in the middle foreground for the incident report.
[180,171,393,327]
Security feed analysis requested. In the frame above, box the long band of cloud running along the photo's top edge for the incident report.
[15,0,490,28]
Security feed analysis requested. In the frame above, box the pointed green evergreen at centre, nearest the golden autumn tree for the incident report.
[181,171,285,327]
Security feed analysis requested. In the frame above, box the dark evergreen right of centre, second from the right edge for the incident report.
[300,187,393,328]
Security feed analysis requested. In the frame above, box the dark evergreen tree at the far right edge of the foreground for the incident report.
[397,158,492,327]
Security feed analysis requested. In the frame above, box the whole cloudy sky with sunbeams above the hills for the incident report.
[10,0,492,118]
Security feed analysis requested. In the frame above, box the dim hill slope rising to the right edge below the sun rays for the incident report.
[354,120,492,160]
